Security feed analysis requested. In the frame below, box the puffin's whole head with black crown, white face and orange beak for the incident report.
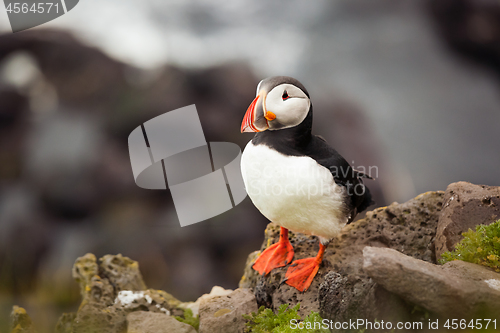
[241,76,311,133]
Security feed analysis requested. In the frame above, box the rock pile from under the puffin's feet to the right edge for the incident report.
[240,182,500,328]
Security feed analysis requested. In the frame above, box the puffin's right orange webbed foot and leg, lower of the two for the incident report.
[285,243,326,291]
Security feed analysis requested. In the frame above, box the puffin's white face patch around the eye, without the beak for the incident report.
[264,83,311,130]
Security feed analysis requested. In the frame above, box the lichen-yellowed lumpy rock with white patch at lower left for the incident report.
[56,253,189,333]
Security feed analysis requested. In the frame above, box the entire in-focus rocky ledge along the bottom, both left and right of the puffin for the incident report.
[12,182,500,333]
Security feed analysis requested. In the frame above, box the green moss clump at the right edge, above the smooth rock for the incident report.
[439,220,500,272]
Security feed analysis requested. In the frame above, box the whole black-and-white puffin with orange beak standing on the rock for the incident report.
[241,76,374,292]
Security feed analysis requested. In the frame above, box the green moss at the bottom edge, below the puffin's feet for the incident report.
[243,303,330,333]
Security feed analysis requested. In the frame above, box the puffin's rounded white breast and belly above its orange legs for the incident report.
[241,141,347,239]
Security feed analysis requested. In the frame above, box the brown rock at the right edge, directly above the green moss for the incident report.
[436,182,500,258]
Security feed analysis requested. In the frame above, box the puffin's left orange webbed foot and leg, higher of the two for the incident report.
[252,227,294,275]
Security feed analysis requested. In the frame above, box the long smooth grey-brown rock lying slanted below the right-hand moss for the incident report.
[363,246,500,318]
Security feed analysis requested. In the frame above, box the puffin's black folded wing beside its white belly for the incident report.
[306,135,374,223]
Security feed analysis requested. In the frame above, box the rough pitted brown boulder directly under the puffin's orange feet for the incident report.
[240,192,444,321]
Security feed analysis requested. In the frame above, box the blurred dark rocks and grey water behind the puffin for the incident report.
[0,0,500,332]
